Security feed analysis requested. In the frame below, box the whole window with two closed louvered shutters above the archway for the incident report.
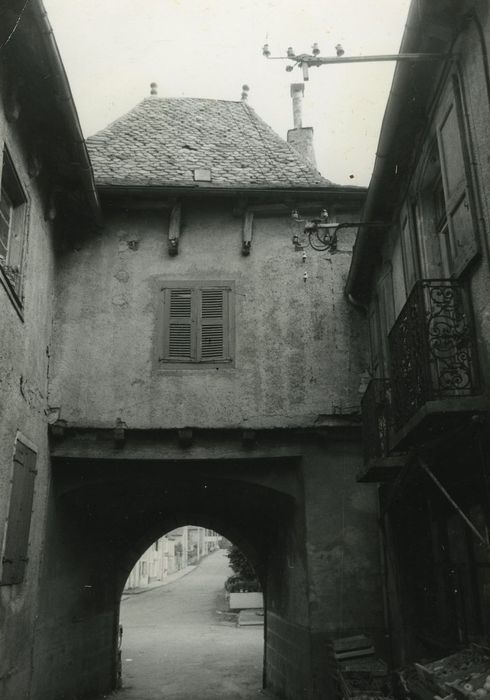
[158,281,234,368]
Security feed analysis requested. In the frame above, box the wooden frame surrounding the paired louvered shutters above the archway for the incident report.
[155,279,235,371]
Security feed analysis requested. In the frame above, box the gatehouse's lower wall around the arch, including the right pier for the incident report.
[33,438,384,700]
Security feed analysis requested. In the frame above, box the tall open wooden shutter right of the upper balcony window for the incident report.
[437,86,478,275]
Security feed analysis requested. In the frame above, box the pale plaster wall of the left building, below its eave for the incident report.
[0,84,53,700]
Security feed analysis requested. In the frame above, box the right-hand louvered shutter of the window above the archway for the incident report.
[197,287,229,362]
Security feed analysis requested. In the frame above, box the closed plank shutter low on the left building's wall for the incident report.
[0,440,36,586]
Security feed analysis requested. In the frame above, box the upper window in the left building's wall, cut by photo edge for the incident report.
[0,149,27,298]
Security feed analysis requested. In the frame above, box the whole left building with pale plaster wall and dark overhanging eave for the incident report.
[0,2,97,699]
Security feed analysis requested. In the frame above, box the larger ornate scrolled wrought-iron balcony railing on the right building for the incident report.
[388,279,480,430]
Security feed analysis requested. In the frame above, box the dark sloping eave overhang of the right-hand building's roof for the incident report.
[345,0,476,303]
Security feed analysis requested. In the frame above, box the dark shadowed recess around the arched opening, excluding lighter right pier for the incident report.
[31,459,308,698]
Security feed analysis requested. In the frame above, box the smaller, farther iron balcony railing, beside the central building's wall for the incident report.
[361,379,392,464]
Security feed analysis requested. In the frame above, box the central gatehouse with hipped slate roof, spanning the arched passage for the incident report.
[35,96,384,700]
